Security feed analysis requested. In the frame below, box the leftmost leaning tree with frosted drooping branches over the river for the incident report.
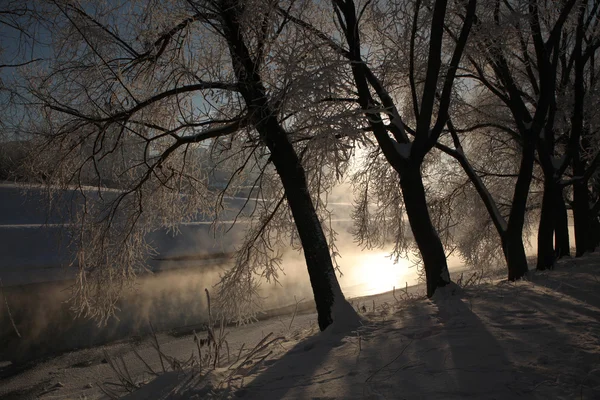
[21,0,358,329]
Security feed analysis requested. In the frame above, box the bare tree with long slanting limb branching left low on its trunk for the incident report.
[432,1,575,280]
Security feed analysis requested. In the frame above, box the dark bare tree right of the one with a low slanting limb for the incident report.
[464,1,597,270]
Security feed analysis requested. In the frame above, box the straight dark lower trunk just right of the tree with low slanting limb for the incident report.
[536,178,556,271]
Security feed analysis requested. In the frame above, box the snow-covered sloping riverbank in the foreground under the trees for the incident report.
[0,254,600,399]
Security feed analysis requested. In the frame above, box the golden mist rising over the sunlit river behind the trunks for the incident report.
[0,180,574,361]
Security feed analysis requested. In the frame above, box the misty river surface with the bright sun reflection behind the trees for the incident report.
[0,227,573,360]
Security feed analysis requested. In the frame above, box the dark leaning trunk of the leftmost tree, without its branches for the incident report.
[220,0,358,330]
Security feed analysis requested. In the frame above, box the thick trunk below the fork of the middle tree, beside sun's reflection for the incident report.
[400,165,450,297]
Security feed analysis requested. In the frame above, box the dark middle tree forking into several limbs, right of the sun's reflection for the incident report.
[280,0,476,296]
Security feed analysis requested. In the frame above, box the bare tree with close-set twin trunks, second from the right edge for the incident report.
[458,1,596,270]
